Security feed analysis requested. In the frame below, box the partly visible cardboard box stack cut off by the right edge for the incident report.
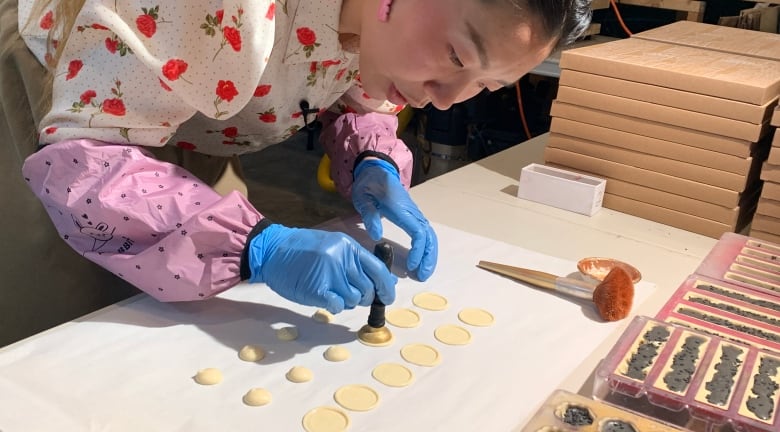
[750,107,780,243]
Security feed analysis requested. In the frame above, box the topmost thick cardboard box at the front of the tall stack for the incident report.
[560,38,780,105]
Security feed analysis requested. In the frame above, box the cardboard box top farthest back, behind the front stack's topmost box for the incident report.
[632,21,780,61]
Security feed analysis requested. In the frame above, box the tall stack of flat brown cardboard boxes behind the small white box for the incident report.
[545,21,780,237]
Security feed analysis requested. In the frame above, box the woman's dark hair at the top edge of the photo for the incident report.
[482,0,593,48]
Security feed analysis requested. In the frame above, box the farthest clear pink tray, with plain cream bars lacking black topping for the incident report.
[696,233,780,297]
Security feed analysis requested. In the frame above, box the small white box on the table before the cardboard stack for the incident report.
[517,163,607,216]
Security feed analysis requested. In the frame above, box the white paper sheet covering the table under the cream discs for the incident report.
[0,219,652,432]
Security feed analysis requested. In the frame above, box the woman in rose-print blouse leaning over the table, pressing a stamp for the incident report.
[19,0,590,313]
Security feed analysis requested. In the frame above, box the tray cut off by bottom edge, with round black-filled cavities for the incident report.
[522,390,682,432]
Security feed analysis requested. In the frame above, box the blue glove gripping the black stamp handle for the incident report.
[248,224,398,314]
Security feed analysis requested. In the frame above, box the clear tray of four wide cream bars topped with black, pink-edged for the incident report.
[593,316,780,432]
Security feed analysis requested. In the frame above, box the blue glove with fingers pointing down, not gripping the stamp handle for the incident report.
[352,159,439,281]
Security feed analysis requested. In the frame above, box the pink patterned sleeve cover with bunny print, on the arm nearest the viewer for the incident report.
[23,139,262,301]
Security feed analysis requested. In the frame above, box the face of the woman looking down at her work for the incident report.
[360,0,555,110]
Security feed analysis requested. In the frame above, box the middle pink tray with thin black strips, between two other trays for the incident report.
[656,275,780,353]
